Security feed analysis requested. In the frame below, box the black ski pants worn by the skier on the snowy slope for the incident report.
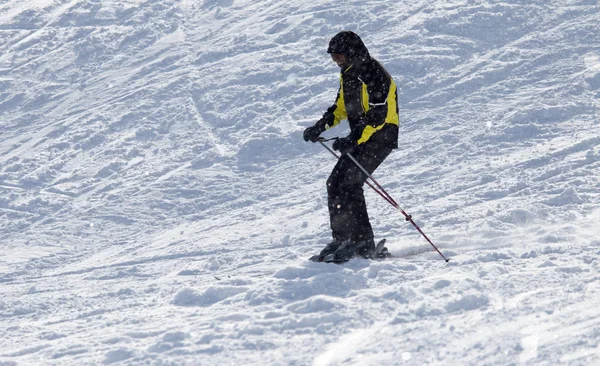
[327,134,392,242]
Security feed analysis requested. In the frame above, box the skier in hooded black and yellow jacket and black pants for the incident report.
[303,30,399,263]
